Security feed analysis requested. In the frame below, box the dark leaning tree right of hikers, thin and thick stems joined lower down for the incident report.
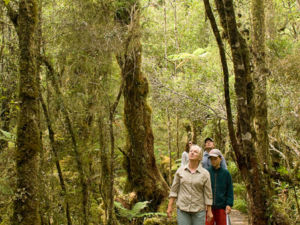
[204,0,287,225]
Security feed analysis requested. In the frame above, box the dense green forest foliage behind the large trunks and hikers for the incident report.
[0,0,300,225]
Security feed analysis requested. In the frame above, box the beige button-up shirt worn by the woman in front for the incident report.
[169,163,213,212]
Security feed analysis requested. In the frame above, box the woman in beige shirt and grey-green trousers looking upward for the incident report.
[167,145,213,225]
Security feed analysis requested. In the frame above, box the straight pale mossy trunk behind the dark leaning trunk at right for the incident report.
[251,0,269,166]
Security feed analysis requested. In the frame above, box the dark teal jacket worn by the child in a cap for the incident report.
[208,166,233,209]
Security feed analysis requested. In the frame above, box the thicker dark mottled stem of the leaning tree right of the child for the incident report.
[224,0,270,222]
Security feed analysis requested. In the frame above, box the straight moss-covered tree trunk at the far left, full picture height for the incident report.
[12,0,40,225]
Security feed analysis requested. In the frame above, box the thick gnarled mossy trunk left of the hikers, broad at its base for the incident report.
[116,0,168,210]
